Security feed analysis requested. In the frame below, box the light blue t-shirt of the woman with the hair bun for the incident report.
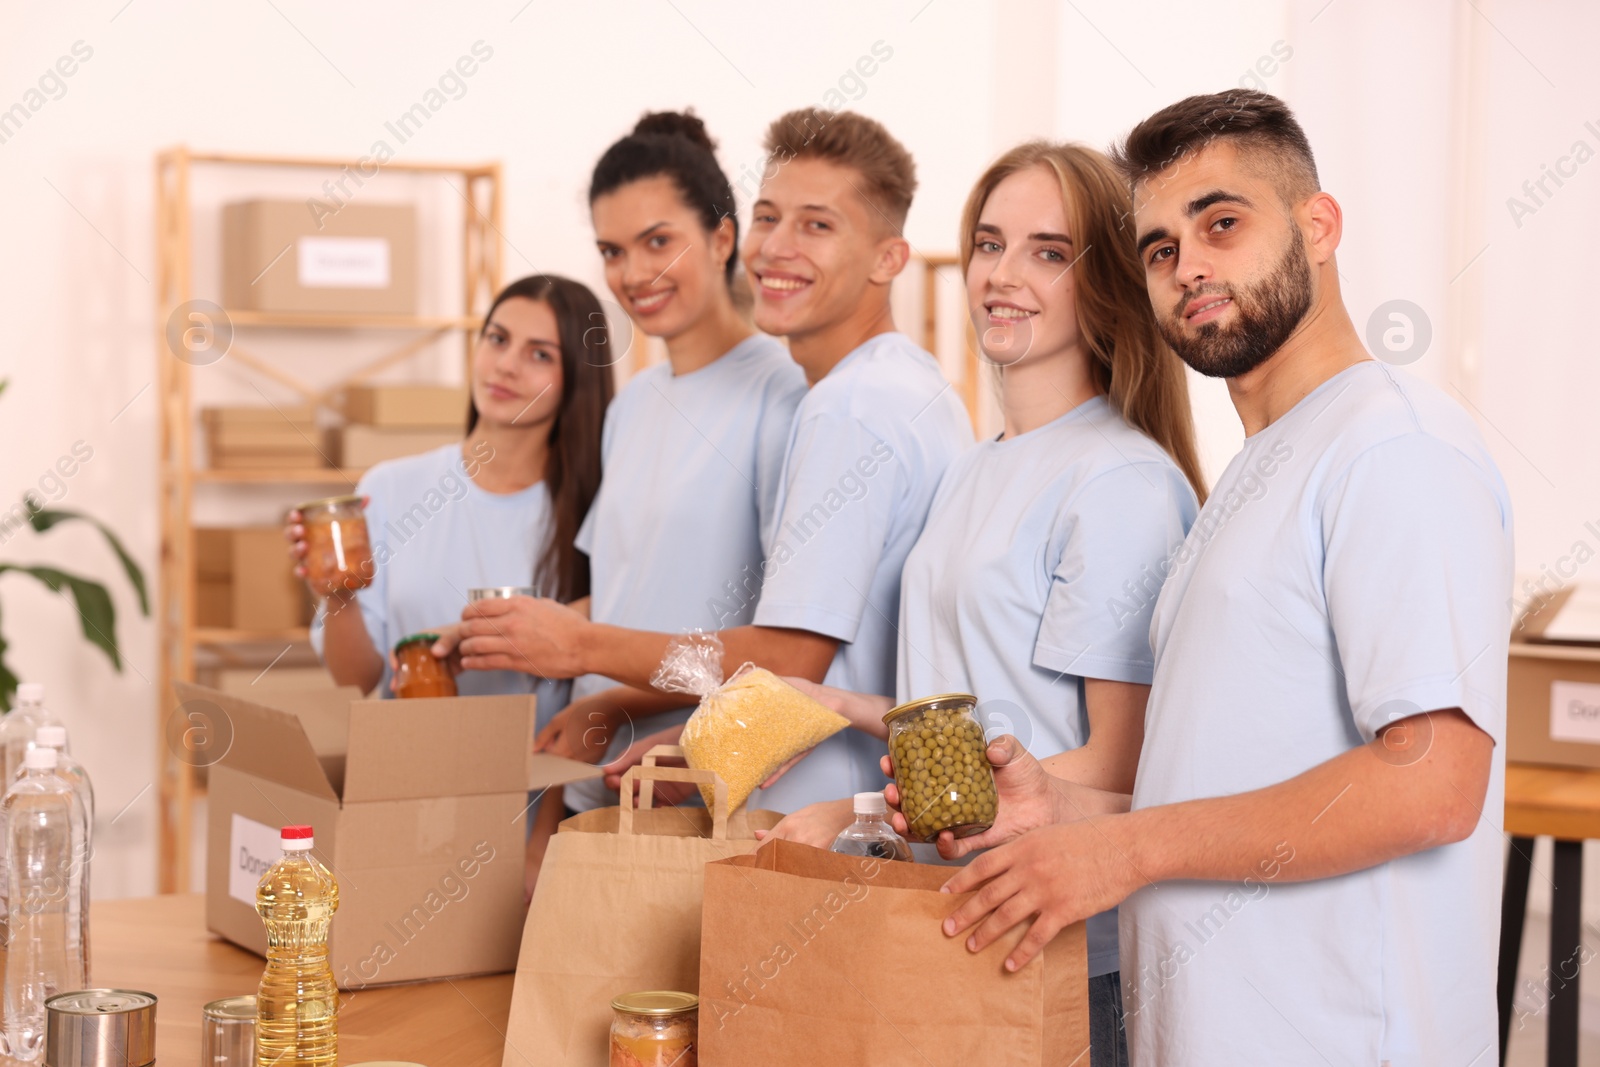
[565,334,805,811]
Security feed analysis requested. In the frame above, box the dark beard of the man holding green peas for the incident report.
[1157,229,1312,378]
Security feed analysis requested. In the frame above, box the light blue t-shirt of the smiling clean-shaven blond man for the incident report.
[749,333,973,813]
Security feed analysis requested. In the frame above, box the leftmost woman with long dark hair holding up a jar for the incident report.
[285,274,613,723]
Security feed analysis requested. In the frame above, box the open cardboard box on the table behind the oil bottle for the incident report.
[176,681,600,989]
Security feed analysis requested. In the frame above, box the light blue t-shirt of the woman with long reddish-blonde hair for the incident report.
[894,397,1198,976]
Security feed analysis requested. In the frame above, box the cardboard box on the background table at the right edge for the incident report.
[1506,589,1600,768]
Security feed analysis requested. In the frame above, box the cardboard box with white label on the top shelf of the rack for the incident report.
[222,200,418,315]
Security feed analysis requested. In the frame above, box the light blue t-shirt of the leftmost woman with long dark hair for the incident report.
[310,445,571,726]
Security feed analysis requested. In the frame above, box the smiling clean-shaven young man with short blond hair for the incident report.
[461,109,973,811]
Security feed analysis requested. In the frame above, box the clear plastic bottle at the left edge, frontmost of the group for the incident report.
[0,747,88,1062]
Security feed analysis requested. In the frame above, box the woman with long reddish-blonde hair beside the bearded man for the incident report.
[773,142,1205,1067]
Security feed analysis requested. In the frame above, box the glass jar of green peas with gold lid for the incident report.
[883,693,998,841]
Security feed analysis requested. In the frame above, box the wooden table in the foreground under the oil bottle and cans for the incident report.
[90,896,512,1067]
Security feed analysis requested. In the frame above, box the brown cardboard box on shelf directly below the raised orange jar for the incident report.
[195,526,312,630]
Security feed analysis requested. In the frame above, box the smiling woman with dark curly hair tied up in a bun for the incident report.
[521,112,806,876]
